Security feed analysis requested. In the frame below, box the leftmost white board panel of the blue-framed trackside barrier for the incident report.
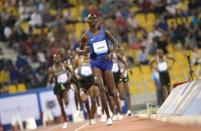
[0,93,40,124]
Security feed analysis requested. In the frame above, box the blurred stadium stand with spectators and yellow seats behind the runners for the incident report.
[0,0,201,130]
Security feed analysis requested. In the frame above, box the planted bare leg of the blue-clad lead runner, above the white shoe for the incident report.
[92,68,110,118]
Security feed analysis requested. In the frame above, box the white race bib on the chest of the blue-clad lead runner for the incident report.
[93,40,108,55]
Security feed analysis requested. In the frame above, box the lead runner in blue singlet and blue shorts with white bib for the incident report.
[80,14,118,125]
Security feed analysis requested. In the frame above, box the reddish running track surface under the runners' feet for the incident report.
[34,117,201,131]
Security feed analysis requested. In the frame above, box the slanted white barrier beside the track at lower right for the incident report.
[157,80,201,116]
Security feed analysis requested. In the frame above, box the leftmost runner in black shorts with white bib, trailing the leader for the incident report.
[48,54,72,128]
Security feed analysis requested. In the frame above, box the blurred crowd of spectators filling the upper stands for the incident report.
[0,0,201,94]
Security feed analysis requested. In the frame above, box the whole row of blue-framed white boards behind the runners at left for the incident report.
[0,88,76,125]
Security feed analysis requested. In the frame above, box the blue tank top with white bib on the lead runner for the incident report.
[87,26,109,60]
